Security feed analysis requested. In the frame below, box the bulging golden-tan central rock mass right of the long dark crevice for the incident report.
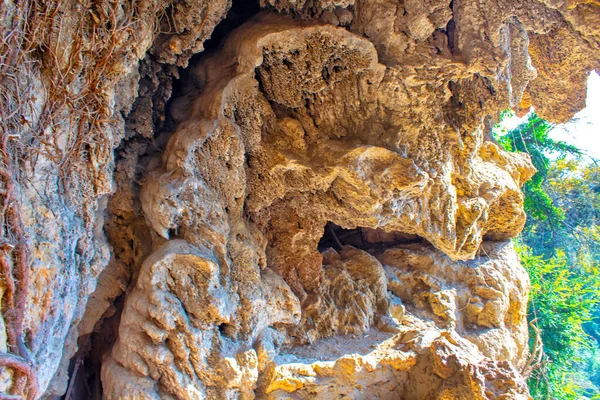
[102,14,533,399]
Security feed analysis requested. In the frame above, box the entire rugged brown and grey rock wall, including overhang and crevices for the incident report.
[0,0,600,400]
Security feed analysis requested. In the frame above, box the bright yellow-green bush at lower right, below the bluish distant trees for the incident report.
[516,243,600,399]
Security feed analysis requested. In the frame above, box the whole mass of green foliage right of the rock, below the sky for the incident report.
[496,110,600,399]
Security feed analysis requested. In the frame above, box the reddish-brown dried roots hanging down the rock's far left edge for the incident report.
[0,1,37,400]
